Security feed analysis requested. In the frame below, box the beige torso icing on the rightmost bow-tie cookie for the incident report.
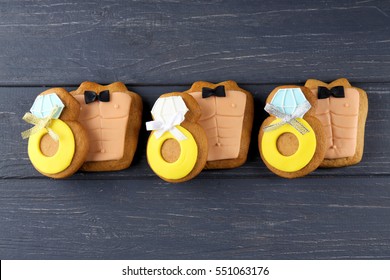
[311,88,359,159]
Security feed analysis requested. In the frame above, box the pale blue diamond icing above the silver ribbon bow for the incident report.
[271,88,307,115]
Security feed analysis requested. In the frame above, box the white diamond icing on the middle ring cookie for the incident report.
[152,96,188,123]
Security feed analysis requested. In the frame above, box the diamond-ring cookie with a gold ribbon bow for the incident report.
[22,88,89,178]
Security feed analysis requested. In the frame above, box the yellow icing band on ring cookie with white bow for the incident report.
[146,126,198,180]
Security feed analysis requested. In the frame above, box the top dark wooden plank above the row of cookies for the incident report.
[0,0,390,85]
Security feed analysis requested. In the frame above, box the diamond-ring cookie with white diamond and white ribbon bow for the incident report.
[146,92,208,183]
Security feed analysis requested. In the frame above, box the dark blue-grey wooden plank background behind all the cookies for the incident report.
[0,0,390,259]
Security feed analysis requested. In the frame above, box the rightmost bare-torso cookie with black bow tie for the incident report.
[305,78,368,167]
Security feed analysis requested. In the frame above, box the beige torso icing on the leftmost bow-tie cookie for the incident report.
[75,92,131,161]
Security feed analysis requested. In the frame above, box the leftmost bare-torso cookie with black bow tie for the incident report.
[71,82,142,171]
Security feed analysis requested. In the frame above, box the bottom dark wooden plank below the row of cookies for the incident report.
[0,176,390,259]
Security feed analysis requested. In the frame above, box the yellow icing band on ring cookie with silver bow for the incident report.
[261,118,317,172]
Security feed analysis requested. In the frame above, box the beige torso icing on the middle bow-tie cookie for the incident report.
[190,90,246,161]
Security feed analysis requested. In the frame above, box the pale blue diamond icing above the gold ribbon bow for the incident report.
[30,93,65,119]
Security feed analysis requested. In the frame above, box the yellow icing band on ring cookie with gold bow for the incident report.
[28,119,75,174]
